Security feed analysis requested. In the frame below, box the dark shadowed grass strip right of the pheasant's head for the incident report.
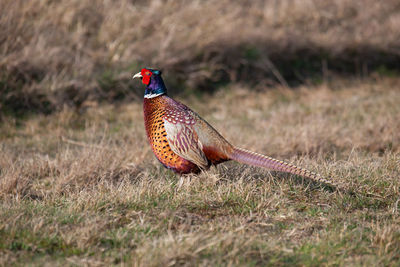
[161,40,400,94]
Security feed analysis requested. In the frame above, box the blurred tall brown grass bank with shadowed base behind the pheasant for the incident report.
[0,0,400,115]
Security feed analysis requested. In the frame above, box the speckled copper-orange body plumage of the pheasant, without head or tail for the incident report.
[143,95,233,174]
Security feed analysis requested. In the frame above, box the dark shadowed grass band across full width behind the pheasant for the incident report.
[0,40,400,117]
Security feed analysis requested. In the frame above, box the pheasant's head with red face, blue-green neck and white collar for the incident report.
[133,68,167,98]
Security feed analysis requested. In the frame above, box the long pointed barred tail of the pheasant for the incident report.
[231,147,343,189]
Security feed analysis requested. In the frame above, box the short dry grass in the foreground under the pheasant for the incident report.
[0,78,400,266]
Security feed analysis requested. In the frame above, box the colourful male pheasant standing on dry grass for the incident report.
[133,68,339,191]
